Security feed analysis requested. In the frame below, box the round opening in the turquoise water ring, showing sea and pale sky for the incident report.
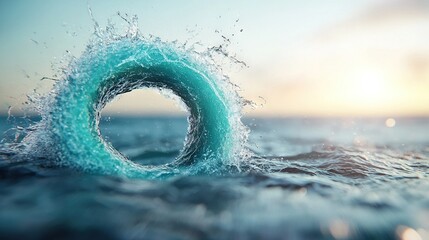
[99,88,188,165]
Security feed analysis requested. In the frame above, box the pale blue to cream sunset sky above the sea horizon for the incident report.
[0,0,429,117]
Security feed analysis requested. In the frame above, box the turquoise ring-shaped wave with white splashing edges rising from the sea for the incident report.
[25,38,247,178]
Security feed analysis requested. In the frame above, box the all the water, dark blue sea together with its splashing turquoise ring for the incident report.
[0,15,429,240]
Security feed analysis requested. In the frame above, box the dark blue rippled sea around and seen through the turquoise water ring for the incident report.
[0,116,429,240]
